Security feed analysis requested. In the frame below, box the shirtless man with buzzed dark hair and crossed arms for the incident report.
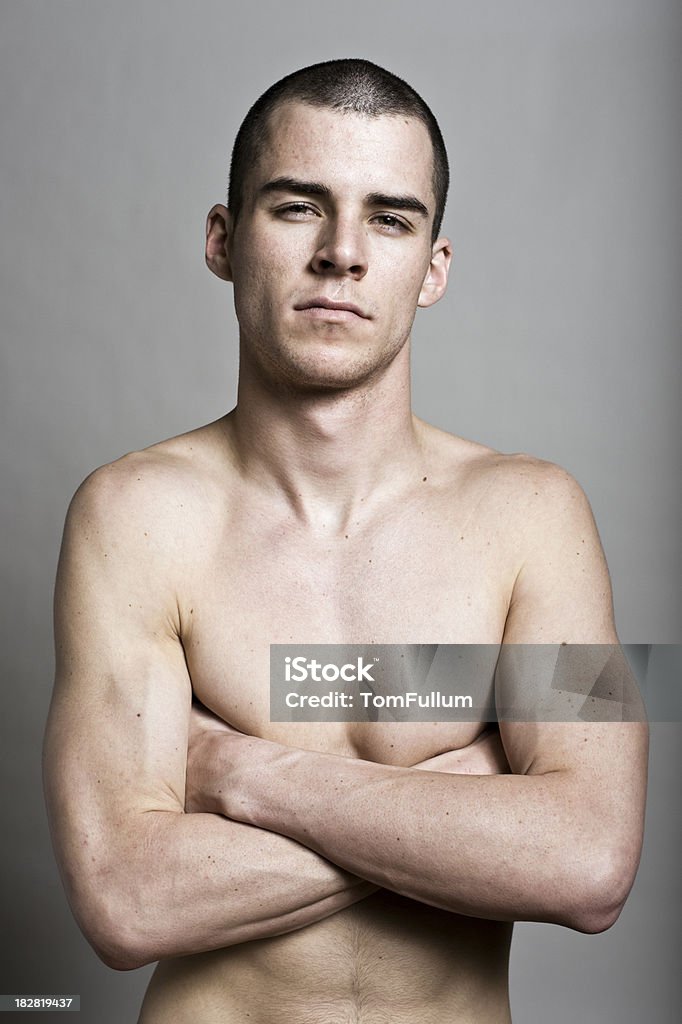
[45,61,646,1024]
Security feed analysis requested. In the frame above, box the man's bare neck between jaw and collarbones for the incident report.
[226,345,423,531]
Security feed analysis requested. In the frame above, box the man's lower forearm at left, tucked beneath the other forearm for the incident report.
[48,798,375,970]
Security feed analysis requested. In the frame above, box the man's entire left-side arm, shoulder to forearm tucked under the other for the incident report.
[45,456,374,969]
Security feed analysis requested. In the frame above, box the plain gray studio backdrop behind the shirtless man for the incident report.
[0,0,682,1024]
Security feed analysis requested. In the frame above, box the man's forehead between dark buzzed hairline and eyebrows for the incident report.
[252,102,433,210]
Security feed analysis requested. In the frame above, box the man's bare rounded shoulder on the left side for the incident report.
[56,425,227,614]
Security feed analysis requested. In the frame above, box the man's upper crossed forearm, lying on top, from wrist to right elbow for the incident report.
[210,729,643,931]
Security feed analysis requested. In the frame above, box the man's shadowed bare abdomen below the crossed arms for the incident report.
[140,891,512,1024]
